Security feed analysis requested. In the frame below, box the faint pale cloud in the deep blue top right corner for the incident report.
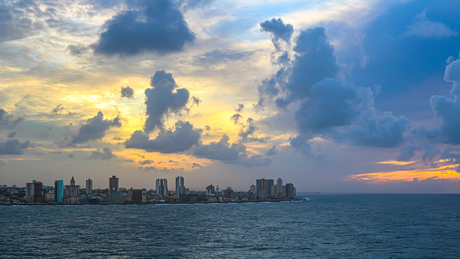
[405,8,458,38]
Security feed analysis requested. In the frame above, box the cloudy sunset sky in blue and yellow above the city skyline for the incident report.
[0,0,460,193]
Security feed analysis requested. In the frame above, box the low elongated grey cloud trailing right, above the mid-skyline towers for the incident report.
[193,135,272,167]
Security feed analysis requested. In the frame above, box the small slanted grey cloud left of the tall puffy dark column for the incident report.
[71,112,121,144]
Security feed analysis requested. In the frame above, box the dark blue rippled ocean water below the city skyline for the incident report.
[0,195,460,258]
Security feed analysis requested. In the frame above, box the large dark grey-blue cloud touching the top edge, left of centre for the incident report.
[94,0,195,56]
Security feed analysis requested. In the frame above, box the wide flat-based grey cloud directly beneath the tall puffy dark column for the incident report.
[125,121,201,154]
